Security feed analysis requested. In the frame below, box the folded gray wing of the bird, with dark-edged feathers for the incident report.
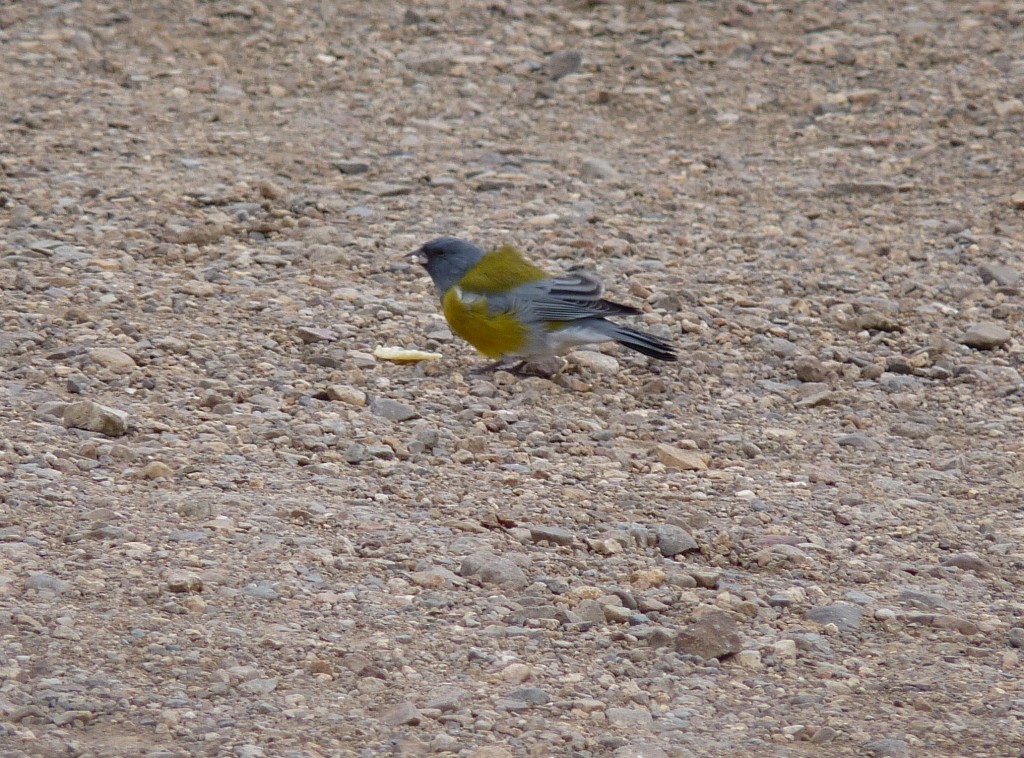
[487,271,639,321]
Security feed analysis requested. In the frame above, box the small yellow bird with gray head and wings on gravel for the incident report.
[407,237,676,372]
